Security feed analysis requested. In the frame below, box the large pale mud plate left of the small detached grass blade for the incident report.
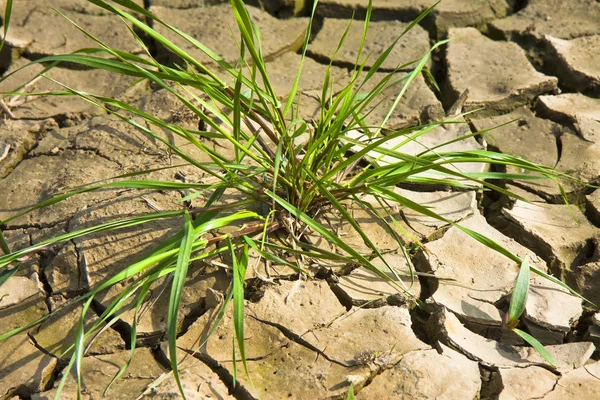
[416,213,545,335]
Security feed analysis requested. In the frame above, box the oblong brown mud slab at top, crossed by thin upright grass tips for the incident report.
[308,18,429,71]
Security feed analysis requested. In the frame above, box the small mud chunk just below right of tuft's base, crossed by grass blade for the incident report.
[332,253,421,308]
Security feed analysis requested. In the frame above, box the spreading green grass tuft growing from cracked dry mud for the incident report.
[0,0,576,398]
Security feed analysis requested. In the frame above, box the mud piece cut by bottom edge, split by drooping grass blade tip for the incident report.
[138,356,235,400]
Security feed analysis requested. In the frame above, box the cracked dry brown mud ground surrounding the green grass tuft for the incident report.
[0,0,600,400]
